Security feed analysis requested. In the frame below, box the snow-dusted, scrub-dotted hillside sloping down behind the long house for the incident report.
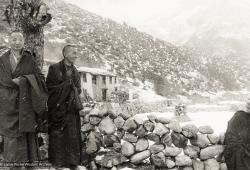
[0,0,250,95]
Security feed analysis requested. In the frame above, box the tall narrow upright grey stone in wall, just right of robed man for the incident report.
[86,132,99,154]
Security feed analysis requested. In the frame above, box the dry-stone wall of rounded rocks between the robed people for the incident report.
[81,104,227,170]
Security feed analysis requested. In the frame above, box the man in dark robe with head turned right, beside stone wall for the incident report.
[46,45,82,169]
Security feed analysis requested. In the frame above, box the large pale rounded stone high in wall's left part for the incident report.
[99,117,116,135]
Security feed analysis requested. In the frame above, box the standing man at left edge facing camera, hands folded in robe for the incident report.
[0,31,47,169]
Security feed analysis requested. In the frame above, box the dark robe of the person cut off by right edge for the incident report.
[224,111,250,170]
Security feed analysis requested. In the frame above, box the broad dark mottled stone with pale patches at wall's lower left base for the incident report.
[95,151,127,168]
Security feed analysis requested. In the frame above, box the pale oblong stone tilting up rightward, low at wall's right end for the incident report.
[200,145,224,160]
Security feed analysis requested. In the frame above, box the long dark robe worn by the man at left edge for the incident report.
[0,50,46,162]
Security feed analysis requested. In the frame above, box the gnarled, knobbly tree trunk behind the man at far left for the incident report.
[5,0,51,69]
